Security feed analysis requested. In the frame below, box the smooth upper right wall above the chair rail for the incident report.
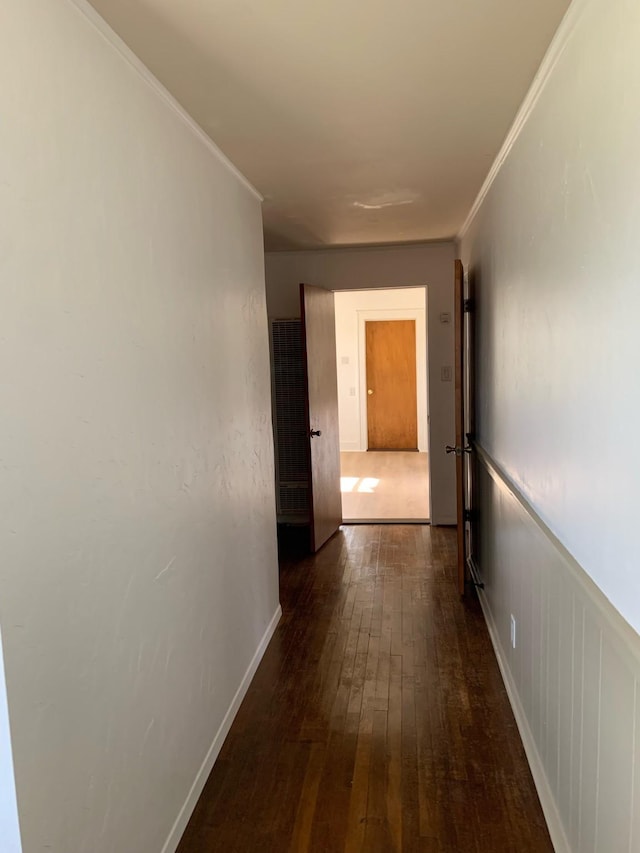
[462,0,640,630]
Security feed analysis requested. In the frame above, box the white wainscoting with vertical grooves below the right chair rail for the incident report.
[476,447,640,853]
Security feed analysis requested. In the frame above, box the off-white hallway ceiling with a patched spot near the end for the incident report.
[91,0,569,250]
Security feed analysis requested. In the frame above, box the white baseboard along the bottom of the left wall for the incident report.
[162,605,282,853]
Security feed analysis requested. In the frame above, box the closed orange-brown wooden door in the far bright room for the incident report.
[365,320,418,450]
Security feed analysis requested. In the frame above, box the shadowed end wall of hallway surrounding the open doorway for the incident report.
[266,242,456,524]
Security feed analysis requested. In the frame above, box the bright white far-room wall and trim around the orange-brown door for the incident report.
[335,287,429,453]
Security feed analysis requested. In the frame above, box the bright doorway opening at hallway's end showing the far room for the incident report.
[335,287,430,523]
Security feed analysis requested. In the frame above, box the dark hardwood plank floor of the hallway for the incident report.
[179,526,553,853]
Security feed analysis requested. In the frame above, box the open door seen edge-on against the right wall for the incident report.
[446,260,475,596]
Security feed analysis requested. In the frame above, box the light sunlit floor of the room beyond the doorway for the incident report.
[340,450,429,522]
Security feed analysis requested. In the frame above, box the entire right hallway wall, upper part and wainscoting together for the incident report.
[461,0,640,853]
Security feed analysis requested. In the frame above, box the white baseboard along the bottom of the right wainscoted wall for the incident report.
[478,589,572,853]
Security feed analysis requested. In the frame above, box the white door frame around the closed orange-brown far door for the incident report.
[356,306,429,453]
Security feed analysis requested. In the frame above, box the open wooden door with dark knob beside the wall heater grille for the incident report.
[300,284,342,552]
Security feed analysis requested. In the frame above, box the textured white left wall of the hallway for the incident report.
[0,0,278,853]
